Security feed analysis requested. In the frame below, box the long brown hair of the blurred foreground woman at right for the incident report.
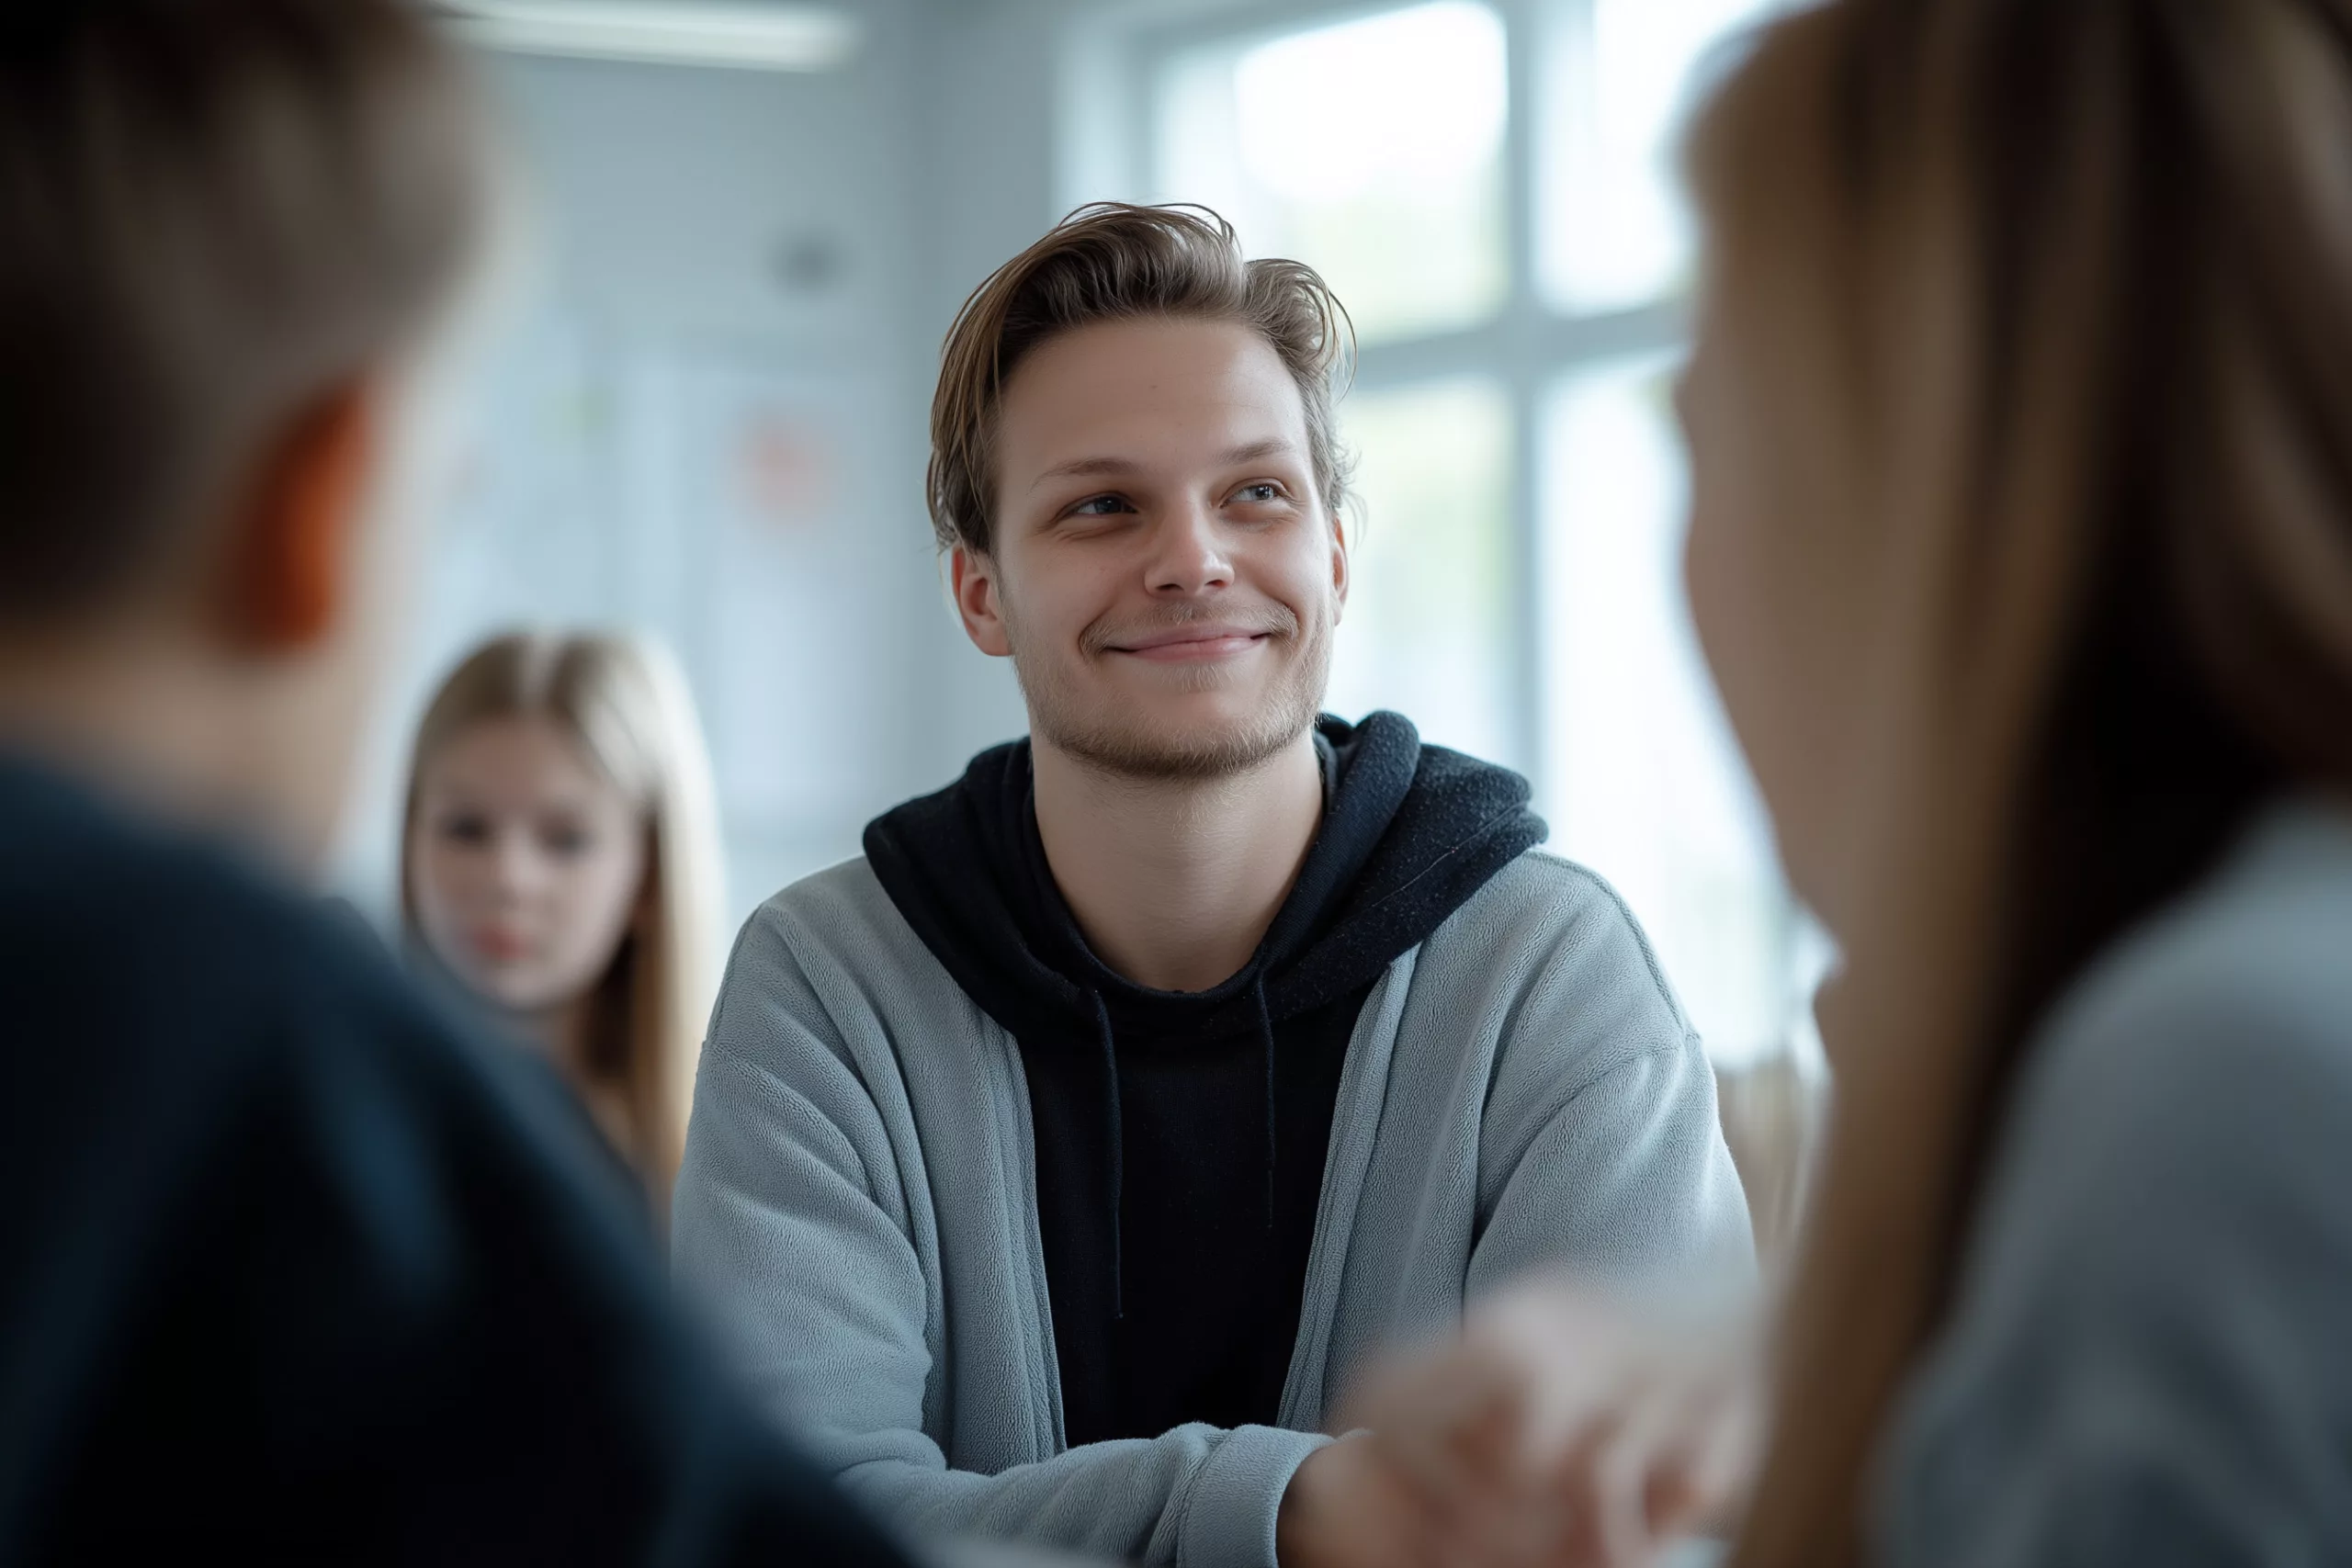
[1691,0,2352,1568]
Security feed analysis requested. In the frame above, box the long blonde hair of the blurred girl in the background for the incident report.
[400,632,722,1218]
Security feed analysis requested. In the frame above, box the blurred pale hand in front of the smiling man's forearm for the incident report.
[1345,1281,1764,1568]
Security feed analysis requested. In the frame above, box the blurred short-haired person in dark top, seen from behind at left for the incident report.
[0,0,896,1563]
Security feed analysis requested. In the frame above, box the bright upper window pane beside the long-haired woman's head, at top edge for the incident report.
[1536,0,1778,310]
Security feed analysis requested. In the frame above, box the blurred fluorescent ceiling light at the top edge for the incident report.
[447,0,858,71]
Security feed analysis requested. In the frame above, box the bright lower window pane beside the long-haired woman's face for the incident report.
[1543,355,1820,1063]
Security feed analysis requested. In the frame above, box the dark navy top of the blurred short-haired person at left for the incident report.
[0,757,899,1568]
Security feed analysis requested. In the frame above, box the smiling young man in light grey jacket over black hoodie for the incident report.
[675,207,1750,1568]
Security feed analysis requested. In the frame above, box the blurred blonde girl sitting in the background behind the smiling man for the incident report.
[400,632,722,1215]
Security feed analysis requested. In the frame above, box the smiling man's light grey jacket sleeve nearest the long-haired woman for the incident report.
[1467,867,1755,1300]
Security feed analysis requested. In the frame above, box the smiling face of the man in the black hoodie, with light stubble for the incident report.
[955,317,1348,778]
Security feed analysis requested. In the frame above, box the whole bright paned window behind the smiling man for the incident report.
[1128,0,1823,1060]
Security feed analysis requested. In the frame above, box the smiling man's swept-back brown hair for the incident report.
[929,202,1352,555]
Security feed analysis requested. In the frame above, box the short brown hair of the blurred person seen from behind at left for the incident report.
[0,0,487,630]
